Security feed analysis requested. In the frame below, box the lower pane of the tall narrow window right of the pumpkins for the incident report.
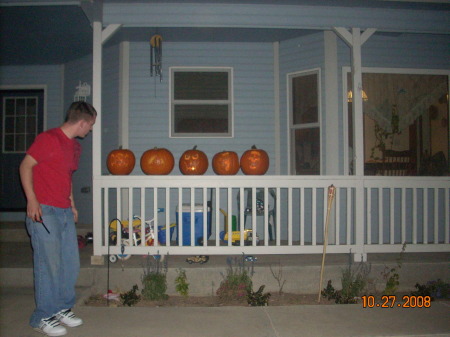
[294,128,320,175]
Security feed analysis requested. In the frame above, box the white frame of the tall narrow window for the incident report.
[286,68,323,175]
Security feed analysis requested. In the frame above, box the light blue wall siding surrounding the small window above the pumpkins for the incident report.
[130,43,275,174]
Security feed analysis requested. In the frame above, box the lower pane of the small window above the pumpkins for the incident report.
[174,105,229,133]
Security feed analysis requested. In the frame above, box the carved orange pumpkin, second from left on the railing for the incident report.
[141,147,175,175]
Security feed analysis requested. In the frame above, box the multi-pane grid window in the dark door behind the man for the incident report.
[2,96,38,153]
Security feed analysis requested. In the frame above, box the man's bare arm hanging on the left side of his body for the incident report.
[19,154,42,221]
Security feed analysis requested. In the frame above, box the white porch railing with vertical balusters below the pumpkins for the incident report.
[94,176,450,259]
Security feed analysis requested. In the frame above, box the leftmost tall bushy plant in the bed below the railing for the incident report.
[141,255,169,301]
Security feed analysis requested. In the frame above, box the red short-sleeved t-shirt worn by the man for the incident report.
[27,128,81,208]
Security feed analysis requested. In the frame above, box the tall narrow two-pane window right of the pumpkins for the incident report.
[288,70,320,175]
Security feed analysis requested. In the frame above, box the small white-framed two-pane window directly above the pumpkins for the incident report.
[170,68,233,137]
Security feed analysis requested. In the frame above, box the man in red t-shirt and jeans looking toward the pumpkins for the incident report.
[20,102,97,336]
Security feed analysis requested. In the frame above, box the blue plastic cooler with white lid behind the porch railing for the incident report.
[176,204,211,246]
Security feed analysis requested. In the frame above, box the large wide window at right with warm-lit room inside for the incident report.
[347,69,450,176]
